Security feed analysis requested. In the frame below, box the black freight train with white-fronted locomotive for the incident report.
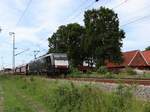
[15,53,69,75]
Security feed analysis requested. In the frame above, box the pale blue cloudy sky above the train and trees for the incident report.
[0,0,150,68]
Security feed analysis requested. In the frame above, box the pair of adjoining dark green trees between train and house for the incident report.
[49,7,125,67]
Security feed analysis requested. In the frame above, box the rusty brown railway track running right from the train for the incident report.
[65,78,150,86]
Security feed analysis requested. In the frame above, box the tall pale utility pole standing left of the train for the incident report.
[9,32,16,73]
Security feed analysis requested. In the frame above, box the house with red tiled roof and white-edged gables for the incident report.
[107,50,150,70]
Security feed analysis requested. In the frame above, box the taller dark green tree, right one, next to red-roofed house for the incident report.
[84,7,125,67]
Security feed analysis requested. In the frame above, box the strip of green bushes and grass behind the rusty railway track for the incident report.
[68,67,150,78]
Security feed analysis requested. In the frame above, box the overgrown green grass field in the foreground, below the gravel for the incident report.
[0,75,150,112]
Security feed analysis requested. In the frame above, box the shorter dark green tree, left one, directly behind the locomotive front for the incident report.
[49,23,85,66]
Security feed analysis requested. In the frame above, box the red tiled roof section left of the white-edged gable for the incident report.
[107,50,140,67]
